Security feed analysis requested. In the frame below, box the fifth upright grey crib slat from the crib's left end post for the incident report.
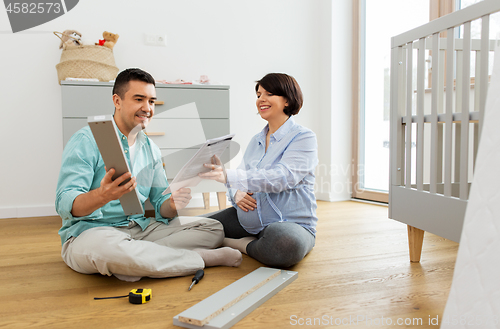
[460,22,471,200]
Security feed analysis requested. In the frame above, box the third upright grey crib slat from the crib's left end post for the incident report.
[429,33,440,193]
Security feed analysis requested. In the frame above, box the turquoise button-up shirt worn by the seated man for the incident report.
[55,120,170,244]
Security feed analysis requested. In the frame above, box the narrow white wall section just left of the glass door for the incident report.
[315,1,353,201]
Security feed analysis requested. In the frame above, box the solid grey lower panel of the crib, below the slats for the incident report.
[390,186,467,242]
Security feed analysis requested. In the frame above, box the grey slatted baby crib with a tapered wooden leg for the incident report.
[389,0,500,262]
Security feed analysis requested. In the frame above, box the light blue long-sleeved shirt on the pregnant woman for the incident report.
[226,117,318,234]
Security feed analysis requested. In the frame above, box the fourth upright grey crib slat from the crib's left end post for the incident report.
[443,28,455,196]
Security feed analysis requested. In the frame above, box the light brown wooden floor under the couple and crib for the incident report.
[0,202,458,329]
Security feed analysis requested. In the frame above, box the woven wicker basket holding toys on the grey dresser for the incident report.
[54,33,118,84]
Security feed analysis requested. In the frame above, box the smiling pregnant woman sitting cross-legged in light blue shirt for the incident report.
[200,73,318,268]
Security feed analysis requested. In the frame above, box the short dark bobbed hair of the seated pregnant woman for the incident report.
[255,73,304,116]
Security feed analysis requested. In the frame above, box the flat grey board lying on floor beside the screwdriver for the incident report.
[174,267,298,329]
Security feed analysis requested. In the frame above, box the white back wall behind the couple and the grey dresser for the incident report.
[0,0,352,218]
